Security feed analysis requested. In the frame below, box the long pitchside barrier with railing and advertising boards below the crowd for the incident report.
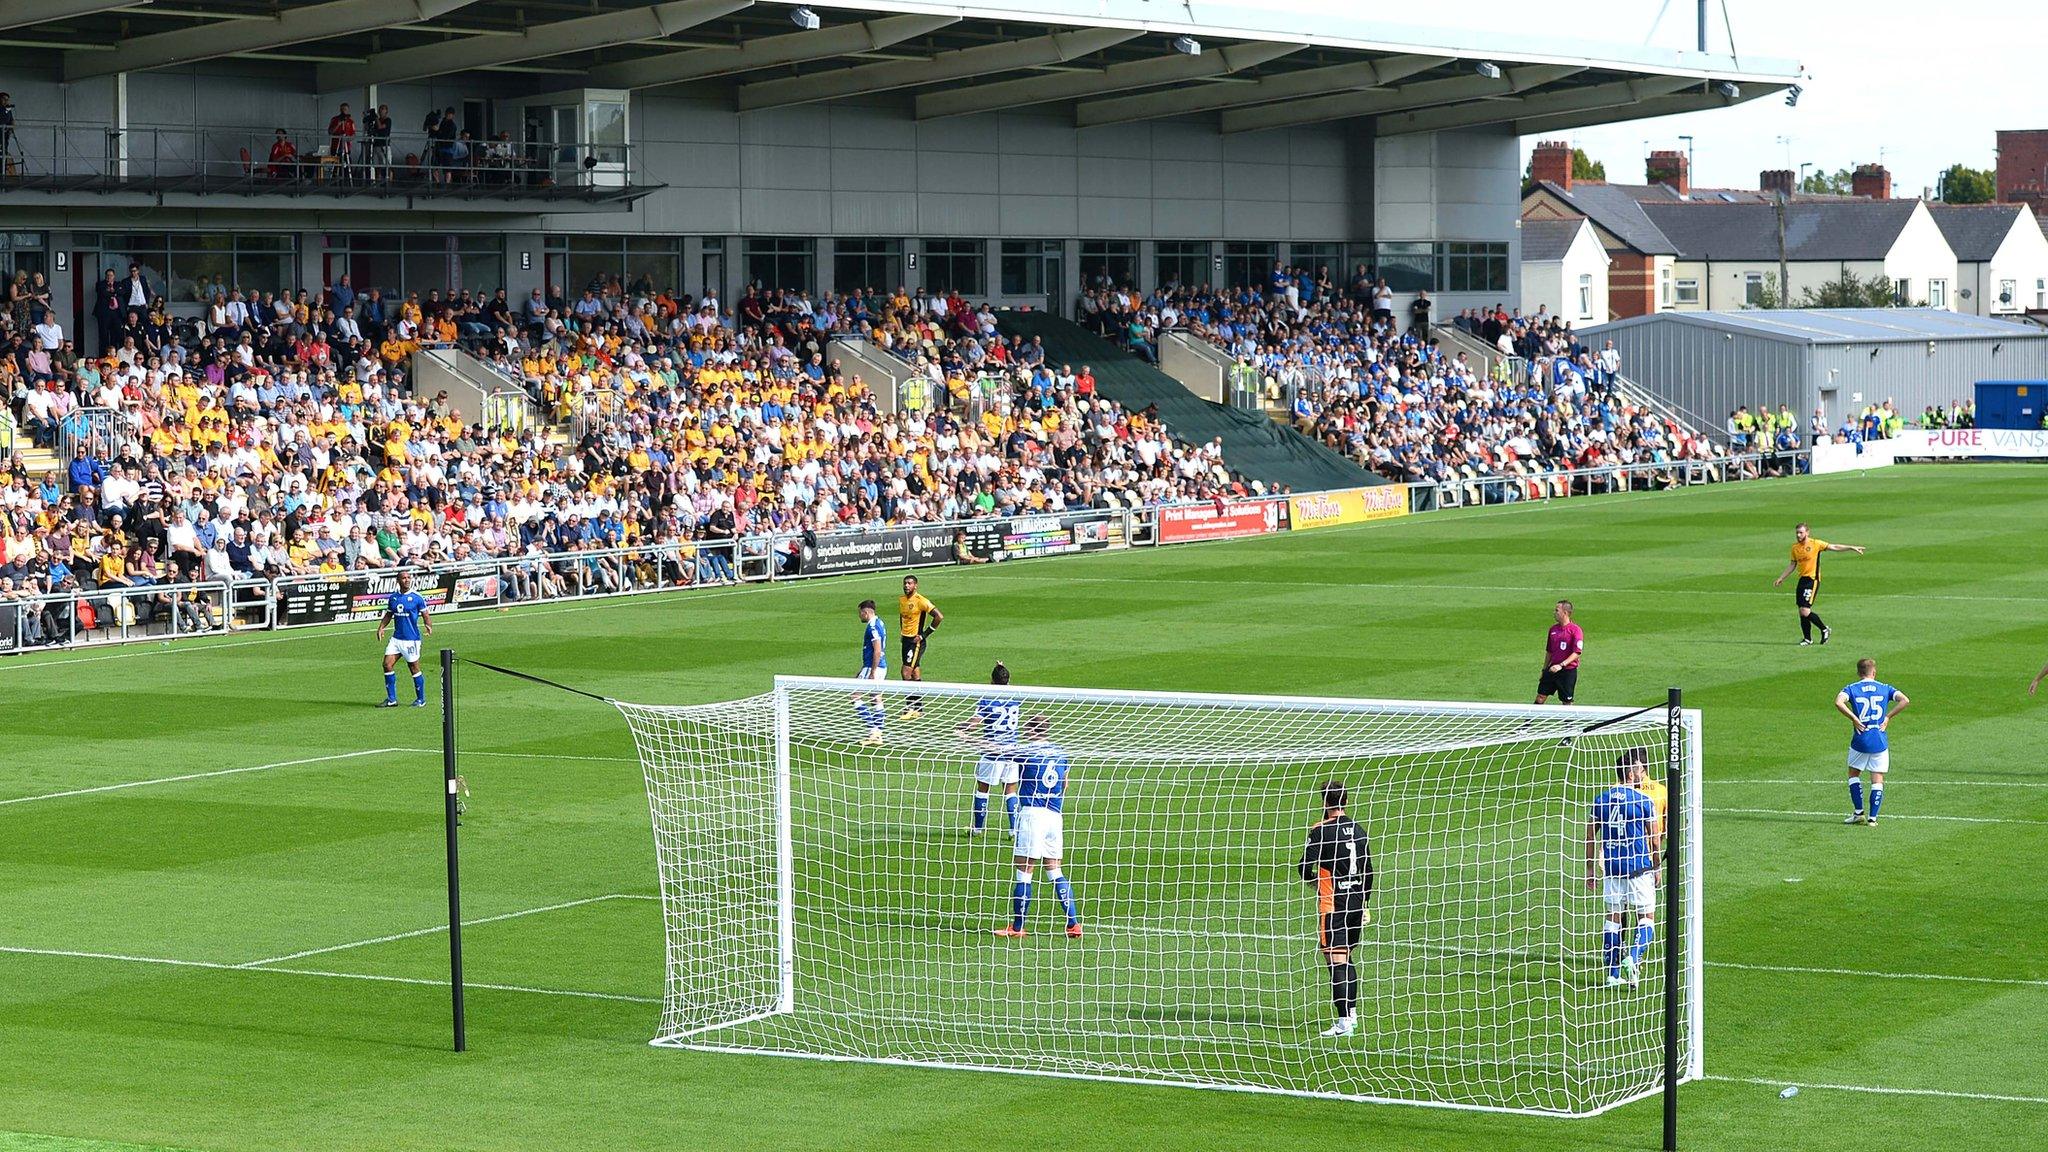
[0,444,1806,652]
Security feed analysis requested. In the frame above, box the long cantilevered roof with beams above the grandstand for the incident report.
[0,0,1798,135]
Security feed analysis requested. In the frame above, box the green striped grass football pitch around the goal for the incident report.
[0,465,2048,1152]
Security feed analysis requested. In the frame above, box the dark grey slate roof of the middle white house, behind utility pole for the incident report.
[1642,199,1919,260]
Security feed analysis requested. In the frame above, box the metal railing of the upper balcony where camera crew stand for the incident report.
[0,121,637,199]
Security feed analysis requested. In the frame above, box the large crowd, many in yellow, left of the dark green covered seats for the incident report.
[0,256,1241,640]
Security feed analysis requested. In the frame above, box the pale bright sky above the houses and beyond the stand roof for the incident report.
[1277,0,2015,197]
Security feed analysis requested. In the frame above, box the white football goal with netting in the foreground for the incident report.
[618,676,1704,1115]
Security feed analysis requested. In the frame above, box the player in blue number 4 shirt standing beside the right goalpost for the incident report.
[1585,756,1663,988]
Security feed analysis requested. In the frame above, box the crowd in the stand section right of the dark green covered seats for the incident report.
[1081,264,1722,498]
